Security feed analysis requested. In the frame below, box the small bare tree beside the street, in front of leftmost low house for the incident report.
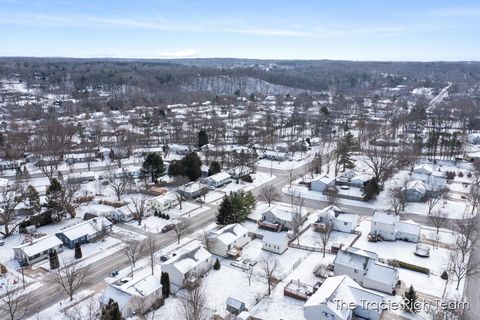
[49,261,89,301]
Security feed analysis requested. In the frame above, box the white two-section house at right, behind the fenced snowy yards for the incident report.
[370,211,422,242]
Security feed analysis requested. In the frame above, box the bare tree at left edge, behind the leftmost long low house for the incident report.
[0,185,24,238]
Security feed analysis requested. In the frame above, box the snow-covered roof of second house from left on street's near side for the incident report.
[164,240,212,274]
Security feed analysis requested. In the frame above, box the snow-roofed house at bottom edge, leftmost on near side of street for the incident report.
[101,274,162,318]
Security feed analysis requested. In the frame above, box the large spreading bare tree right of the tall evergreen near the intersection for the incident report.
[362,146,395,183]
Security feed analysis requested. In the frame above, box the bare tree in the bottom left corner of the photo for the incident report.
[0,279,31,320]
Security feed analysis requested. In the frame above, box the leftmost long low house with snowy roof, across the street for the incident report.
[13,235,63,265]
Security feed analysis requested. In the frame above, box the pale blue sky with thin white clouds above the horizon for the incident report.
[0,0,480,61]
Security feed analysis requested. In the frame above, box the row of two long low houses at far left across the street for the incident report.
[13,217,112,265]
